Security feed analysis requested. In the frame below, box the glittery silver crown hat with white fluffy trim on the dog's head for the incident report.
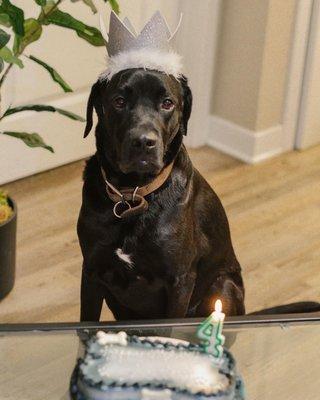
[100,11,182,79]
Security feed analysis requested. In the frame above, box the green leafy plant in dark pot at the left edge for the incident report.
[0,0,119,299]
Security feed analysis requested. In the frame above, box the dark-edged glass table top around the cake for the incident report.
[0,314,320,400]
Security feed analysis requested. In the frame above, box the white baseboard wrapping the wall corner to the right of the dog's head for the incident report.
[207,116,283,164]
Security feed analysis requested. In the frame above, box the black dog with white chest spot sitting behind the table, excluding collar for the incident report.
[78,69,245,321]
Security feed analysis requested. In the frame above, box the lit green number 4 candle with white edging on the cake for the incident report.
[197,300,225,359]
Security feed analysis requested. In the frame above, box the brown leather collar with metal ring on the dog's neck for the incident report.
[101,161,174,219]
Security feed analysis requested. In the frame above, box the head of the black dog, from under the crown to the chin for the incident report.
[84,69,192,176]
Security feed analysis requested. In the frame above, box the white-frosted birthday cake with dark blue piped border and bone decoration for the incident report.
[70,331,244,400]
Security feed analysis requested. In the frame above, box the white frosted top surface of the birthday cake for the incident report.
[80,332,229,395]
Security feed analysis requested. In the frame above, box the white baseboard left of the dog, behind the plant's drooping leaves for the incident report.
[0,90,95,184]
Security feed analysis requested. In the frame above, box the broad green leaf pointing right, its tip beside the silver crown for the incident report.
[45,10,105,46]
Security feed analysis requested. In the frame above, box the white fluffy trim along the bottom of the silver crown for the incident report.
[100,48,182,79]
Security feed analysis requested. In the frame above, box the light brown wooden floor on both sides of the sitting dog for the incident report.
[0,146,320,323]
